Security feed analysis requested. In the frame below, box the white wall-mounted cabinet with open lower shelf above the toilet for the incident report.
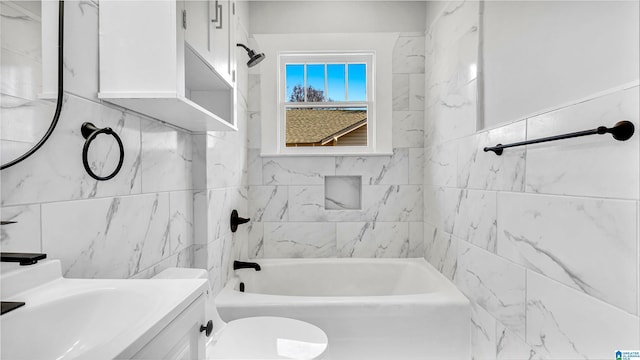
[98,0,237,132]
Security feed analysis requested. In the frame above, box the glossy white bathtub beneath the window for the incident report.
[215,259,470,360]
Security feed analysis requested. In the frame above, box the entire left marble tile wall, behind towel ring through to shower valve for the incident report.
[0,1,248,289]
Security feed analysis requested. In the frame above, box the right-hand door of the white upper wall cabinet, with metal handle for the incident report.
[211,0,236,82]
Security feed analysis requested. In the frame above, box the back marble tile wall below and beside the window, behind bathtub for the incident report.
[247,33,425,258]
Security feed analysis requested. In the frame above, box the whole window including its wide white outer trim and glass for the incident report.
[253,33,398,156]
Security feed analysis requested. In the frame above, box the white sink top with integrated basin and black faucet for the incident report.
[0,260,206,359]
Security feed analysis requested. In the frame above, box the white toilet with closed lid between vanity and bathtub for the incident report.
[154,268,328,360]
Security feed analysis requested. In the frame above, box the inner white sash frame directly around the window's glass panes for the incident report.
[278,52,376,154]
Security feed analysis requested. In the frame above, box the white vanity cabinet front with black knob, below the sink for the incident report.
[131,295,207,360]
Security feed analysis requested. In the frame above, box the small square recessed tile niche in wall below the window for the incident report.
[324,176,362,210]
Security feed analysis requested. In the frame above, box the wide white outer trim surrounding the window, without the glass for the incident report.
[254,33,398,156]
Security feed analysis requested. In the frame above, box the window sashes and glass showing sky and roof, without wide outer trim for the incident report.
[280,53,375,149]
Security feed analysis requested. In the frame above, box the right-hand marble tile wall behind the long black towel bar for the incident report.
[424,1,640,360]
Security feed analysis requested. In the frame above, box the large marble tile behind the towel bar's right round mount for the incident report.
[526,86,640,199]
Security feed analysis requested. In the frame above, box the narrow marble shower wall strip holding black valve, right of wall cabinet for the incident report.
[192,1,250,294]
